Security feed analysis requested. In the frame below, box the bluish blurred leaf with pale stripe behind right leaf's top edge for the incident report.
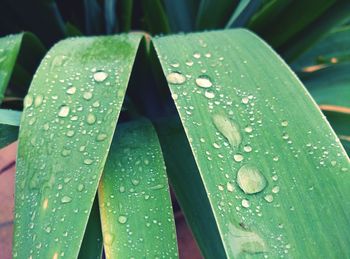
[226,0,263,28]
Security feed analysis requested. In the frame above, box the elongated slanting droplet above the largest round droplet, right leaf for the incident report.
[213,114,242,148]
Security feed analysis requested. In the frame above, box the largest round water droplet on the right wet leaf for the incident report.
[237,165,267,194]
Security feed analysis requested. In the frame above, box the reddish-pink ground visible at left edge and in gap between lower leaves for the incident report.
[0,143,202,259]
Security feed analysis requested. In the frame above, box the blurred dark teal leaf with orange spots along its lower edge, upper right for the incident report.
[292,26,350,70]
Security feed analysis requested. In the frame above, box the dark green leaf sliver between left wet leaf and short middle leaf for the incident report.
[78,196,103,259]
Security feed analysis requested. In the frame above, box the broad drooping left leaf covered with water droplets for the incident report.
[13,34,142,258]
